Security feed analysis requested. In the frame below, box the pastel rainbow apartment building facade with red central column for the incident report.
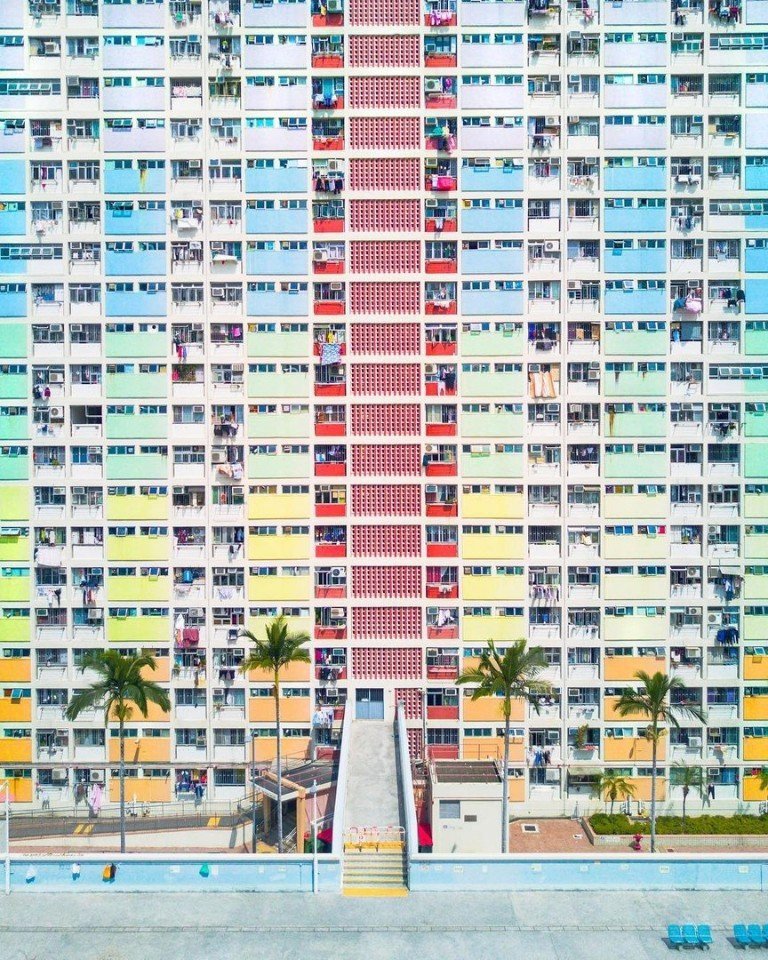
[0,0,768,811]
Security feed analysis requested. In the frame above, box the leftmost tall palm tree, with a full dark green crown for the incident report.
[66,650,171,853]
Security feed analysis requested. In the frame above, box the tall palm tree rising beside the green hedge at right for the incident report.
[616,670,706,853]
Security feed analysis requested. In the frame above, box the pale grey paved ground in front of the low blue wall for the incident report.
[0,891,768,960]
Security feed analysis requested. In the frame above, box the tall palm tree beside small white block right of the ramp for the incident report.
[457,640,549,853]
